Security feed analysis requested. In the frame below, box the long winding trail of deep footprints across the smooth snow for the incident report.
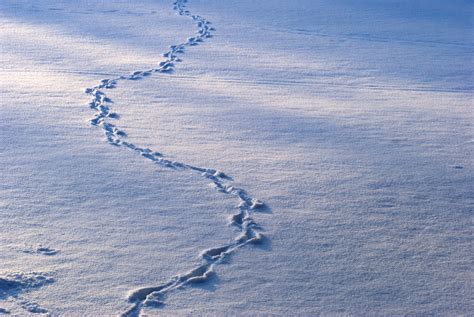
[85,0,266,317]
